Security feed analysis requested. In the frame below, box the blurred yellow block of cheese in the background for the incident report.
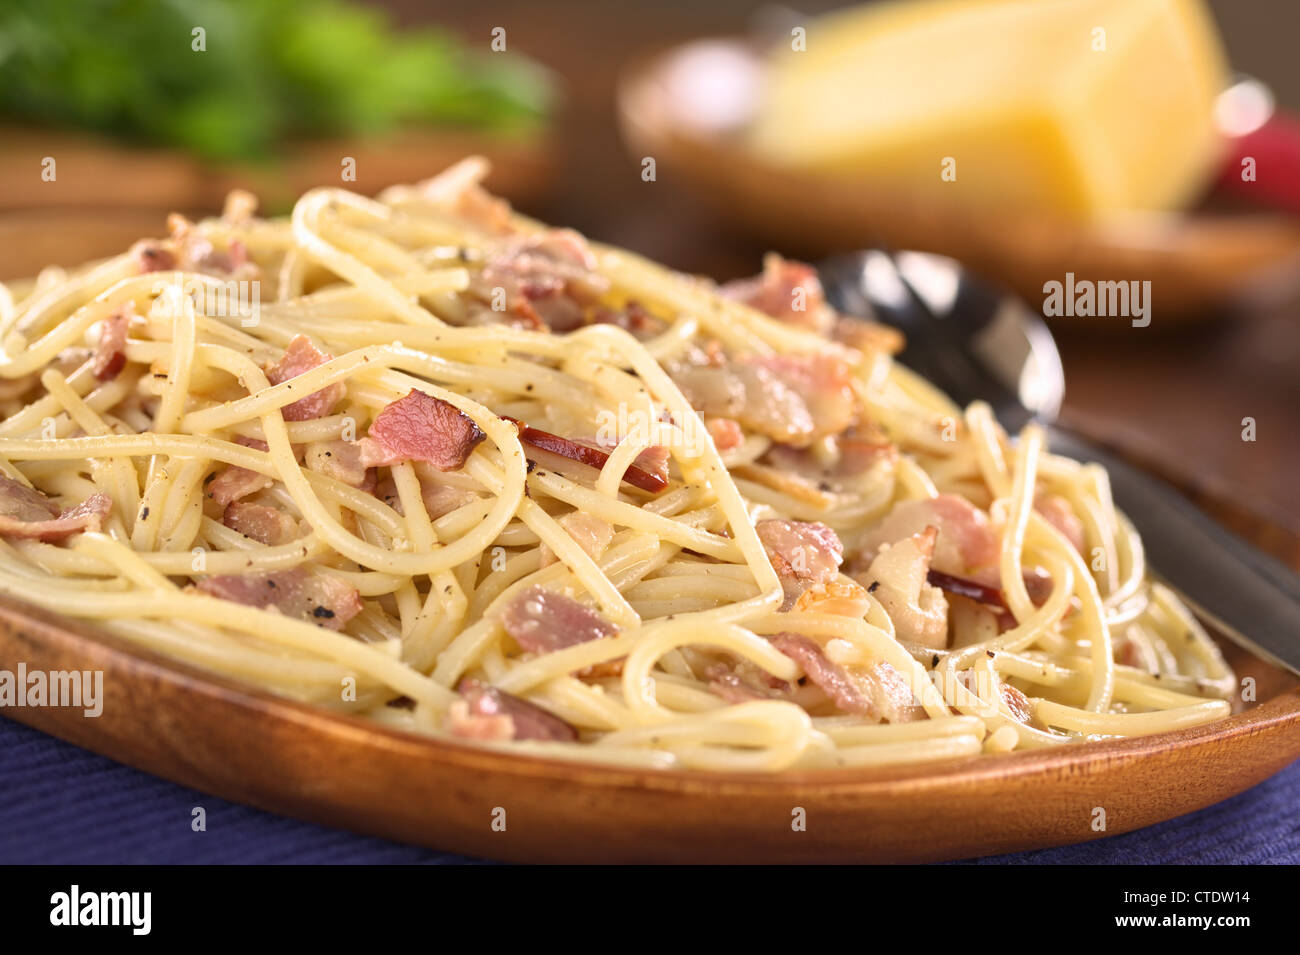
[749,0,1227,221]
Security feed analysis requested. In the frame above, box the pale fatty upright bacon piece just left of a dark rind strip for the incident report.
[858,526,948,648]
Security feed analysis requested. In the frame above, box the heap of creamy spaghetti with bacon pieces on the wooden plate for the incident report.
[0,160,1234,770]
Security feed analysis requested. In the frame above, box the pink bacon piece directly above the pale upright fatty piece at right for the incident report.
[863,494,998,585]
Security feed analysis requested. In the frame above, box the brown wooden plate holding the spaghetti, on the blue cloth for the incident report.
[0,485,1300,863]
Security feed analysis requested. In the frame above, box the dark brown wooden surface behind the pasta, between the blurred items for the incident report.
[382,0,1300,530]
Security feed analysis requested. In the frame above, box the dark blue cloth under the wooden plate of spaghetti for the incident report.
[0,717,1300,865]
